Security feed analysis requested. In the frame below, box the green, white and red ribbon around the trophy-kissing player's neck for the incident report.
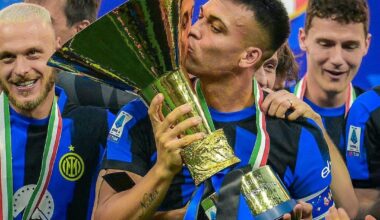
[195,79,270,169]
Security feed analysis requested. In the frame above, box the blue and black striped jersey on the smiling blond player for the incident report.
[10,87,114,219]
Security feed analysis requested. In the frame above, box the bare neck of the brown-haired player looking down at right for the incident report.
[305,79,348,108]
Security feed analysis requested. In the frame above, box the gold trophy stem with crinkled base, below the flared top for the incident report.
[140,69,240,185]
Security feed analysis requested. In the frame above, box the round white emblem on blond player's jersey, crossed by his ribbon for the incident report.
[13,184,54,220]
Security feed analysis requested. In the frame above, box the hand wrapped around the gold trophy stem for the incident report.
[148,94,205,176]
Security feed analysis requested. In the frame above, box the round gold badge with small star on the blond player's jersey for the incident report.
[59,145,85,181]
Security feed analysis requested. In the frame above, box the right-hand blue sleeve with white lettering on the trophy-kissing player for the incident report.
[284,119,334,218]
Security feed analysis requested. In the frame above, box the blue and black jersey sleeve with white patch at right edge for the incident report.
[345,90,380,188]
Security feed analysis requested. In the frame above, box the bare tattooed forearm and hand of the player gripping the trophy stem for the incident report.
[93,95,204,219]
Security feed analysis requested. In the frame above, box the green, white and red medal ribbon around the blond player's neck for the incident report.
[0,93,62,220]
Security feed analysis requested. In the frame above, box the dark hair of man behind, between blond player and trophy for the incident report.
[64,0,101,26]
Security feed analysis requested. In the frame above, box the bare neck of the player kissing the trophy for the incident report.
[200,74,254,112]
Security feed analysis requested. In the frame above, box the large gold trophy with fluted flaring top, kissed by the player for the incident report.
[49,0,240,185]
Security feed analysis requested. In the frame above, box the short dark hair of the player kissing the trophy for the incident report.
[234,0,290,60]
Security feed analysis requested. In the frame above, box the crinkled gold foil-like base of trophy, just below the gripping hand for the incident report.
[181,129,240,185]
